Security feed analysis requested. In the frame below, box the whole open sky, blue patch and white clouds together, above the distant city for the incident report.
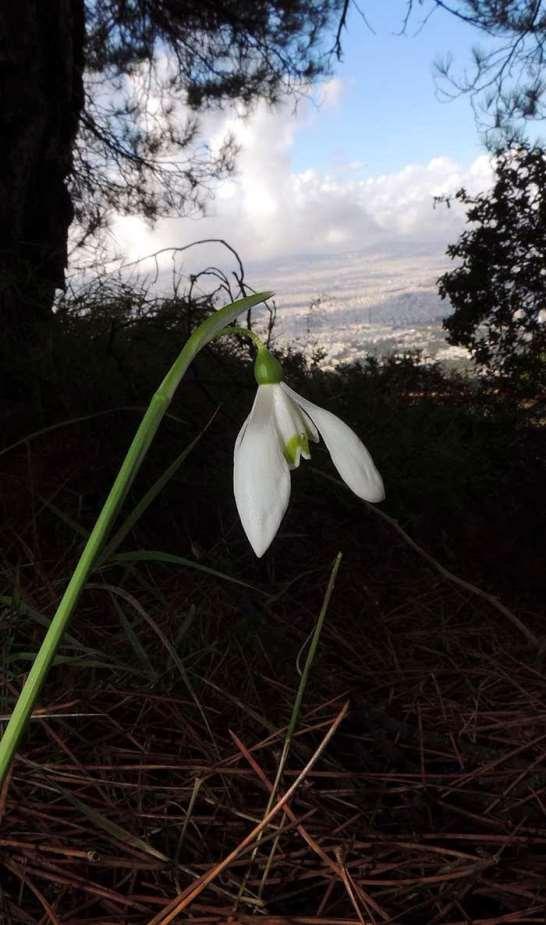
[112,0,498,280]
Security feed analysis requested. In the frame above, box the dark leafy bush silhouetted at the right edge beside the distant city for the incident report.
[439,145,546,393]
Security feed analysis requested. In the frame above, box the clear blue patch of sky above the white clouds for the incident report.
[293,0,482,174]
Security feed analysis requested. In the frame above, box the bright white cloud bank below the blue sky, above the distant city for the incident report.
[108,89,492,278]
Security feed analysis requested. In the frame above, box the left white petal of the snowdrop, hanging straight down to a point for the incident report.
[233,385,290,557]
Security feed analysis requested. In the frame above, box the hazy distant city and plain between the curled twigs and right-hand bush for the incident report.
[247,247,468,368]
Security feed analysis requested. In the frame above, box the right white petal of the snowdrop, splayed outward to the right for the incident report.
[281,382,385,502]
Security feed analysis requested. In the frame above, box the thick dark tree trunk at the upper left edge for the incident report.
[0,0,84,355]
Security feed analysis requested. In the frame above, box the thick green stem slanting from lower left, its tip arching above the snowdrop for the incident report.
[0,292,272,785]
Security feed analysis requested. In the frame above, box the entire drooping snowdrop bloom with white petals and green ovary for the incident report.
[233,346,385,556]
